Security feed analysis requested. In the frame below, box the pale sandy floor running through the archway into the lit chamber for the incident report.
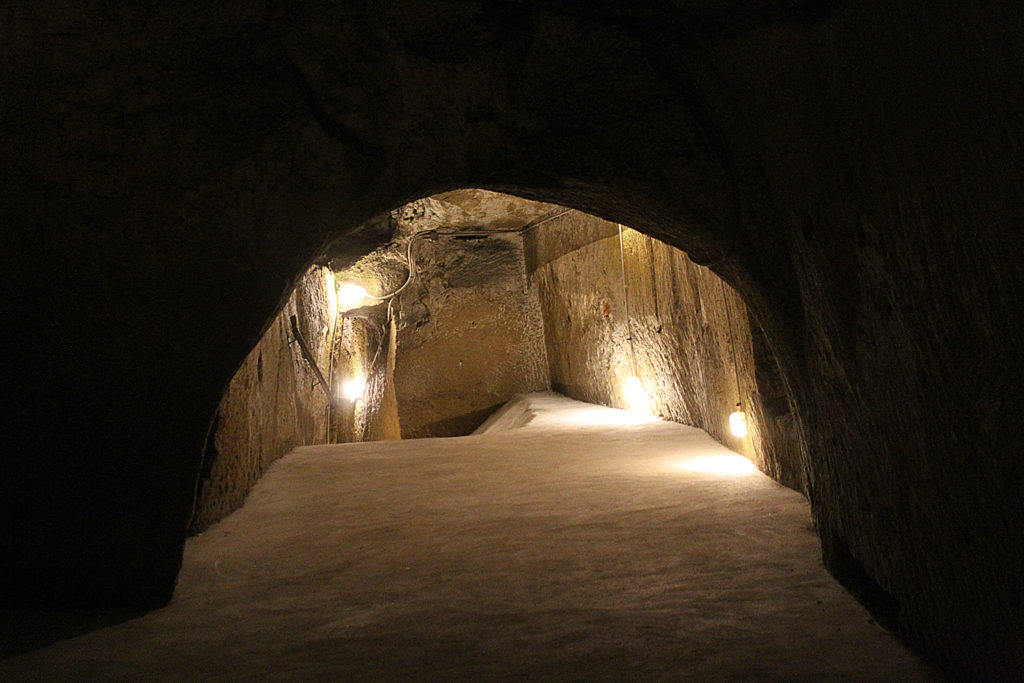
[0,395,930,681]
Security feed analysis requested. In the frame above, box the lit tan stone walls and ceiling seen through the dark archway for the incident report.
[190,190,790,532]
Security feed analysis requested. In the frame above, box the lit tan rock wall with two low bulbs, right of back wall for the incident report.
[525,212,804,489]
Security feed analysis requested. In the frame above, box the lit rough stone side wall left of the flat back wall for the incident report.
[188,266,401,533]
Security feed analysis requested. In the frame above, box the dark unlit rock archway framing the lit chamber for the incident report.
[0,0,1024,673]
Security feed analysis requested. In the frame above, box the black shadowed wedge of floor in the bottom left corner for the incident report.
[0,609,147,658]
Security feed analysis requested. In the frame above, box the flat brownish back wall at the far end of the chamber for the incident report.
[395,236,549,438]
